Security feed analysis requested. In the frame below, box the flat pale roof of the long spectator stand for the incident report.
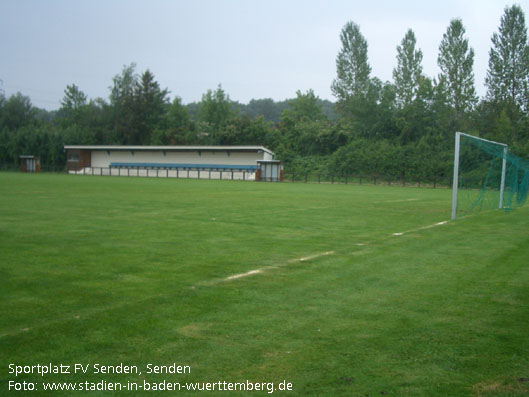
[64,145,274,155]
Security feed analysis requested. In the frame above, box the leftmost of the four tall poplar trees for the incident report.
[331,22,371,104]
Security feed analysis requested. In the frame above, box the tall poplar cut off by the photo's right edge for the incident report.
[485,5,529,110]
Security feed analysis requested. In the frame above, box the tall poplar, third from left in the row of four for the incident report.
[437,18,477,117]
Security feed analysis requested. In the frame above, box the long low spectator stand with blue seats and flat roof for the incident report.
[64,145,282,180]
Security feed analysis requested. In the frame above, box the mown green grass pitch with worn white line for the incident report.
[0,173,529,396]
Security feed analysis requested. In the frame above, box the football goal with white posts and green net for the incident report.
[452,132,529,219]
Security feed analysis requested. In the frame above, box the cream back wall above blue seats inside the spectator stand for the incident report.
[91,150,272,167]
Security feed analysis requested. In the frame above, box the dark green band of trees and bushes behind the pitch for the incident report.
[0,5,529,181]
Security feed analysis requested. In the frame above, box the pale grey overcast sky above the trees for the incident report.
[0,0,529,110]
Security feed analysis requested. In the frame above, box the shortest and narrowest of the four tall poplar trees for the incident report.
[393,29,422,106]
